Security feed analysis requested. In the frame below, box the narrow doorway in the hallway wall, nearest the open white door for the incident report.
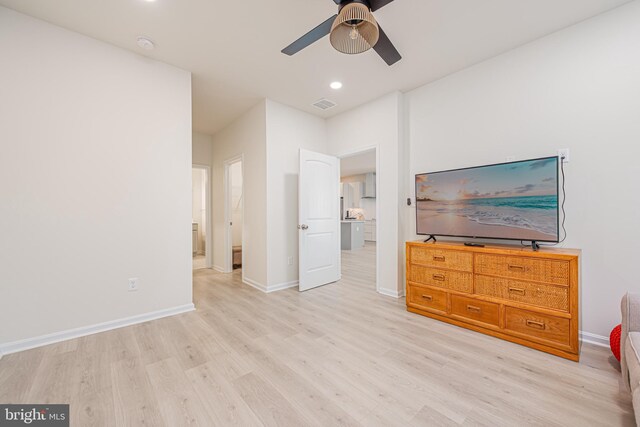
[225,156,244,273]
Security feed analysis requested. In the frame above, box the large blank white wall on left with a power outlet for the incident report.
[0,7,192,346]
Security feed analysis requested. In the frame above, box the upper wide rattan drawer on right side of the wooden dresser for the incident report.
[475,254,569,285]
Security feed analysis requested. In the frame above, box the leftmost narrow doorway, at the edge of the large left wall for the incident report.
[191,165,211,270]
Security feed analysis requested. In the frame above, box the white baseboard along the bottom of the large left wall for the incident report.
[0,303,196,357]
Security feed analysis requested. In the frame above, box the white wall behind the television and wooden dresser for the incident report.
[406,2,640,342]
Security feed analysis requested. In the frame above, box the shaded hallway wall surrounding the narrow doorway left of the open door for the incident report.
[211,101,267,290]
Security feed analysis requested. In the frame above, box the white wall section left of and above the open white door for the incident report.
[266,100,327,290]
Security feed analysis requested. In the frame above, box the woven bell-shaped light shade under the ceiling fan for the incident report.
[330,3,380,55]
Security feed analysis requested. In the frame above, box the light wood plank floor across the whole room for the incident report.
[0,245,634,427]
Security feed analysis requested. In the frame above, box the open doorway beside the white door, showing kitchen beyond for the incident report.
[340,147,379,291]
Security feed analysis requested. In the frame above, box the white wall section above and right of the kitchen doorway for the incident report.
[327,92,404,296]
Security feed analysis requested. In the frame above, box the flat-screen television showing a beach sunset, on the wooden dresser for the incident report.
[416,157,559,242]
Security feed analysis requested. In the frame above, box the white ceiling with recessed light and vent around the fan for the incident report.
[0,0,629,134]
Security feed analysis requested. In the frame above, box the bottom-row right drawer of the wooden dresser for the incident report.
[505,307,570,346]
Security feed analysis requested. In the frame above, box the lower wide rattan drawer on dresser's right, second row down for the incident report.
[475,275,569,311]
